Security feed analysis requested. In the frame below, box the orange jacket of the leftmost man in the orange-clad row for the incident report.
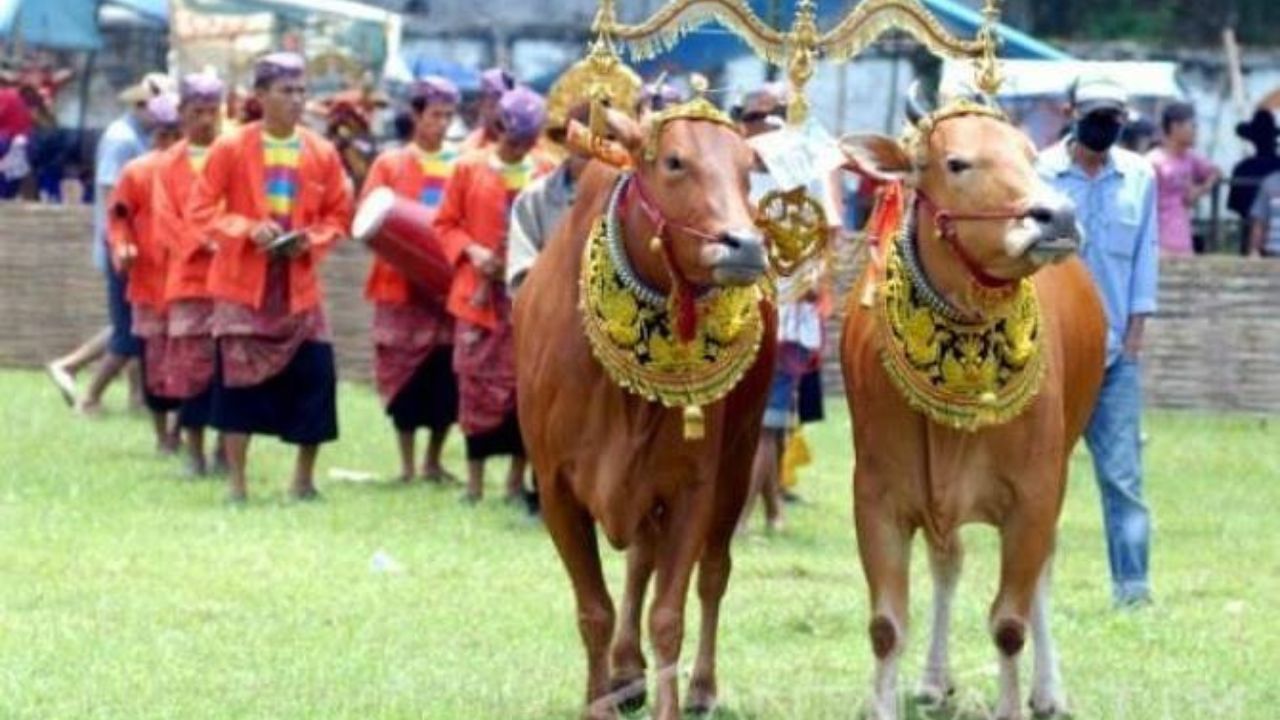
[106,150,168,310]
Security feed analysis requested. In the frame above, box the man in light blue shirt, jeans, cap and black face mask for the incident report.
[1038,78,1160,607]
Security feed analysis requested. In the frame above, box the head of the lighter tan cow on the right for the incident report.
[842,91,1080,286]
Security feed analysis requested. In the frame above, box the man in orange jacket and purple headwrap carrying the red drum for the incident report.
[361,76,458,483]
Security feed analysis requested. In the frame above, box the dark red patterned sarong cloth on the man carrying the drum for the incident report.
[372,302,453,404]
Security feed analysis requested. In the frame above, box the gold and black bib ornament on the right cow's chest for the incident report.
[877,221,1044,432]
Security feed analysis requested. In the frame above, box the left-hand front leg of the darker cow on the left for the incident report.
[539,475,617,720]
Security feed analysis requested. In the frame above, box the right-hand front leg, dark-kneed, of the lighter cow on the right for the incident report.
[991,507,1055,720]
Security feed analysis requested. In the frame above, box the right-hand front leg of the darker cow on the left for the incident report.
[649,482,716,720]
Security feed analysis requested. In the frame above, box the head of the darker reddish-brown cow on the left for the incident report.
[596,99,765,287]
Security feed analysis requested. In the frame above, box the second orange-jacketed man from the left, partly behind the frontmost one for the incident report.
[152,73,225,477]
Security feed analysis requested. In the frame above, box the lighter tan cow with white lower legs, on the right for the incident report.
[841,96,1106,719]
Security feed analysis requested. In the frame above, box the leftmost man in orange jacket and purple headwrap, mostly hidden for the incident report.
[106,94,182,454]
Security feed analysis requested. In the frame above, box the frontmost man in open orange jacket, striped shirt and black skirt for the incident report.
[188,53,351,502]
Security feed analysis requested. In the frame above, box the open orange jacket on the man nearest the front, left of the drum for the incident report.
[187,123,351,313]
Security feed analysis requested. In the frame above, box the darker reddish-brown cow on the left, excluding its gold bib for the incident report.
[515,106,776,719]
